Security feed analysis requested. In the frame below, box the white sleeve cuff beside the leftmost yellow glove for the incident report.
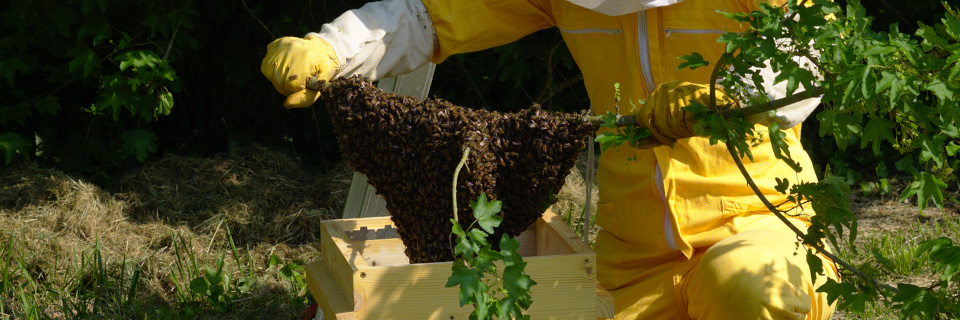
[310,0,436,80]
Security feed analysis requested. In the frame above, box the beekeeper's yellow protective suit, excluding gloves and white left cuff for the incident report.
[423,0,836,319]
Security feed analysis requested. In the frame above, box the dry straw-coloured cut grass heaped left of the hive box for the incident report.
[0,148,349,316]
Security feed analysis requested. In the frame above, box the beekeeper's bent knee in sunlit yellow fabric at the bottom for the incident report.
[684,230,837,320]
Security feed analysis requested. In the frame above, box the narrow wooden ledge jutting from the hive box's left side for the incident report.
[303,255,354,320]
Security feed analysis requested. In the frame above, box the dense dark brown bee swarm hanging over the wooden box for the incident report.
[321,77,596,263]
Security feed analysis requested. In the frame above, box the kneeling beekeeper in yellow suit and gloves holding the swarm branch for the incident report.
[261,0,837,319]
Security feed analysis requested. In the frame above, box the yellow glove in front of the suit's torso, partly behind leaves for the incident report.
[637,81,736,148]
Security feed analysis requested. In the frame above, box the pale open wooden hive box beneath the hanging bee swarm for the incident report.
[305,211,613,320]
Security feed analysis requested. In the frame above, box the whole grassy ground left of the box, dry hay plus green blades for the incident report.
[0,148,349,319]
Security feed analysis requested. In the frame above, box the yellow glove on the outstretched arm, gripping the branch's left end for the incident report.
[260,35,340,109]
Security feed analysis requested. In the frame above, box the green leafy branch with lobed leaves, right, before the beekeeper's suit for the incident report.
[598,0,960,319]
